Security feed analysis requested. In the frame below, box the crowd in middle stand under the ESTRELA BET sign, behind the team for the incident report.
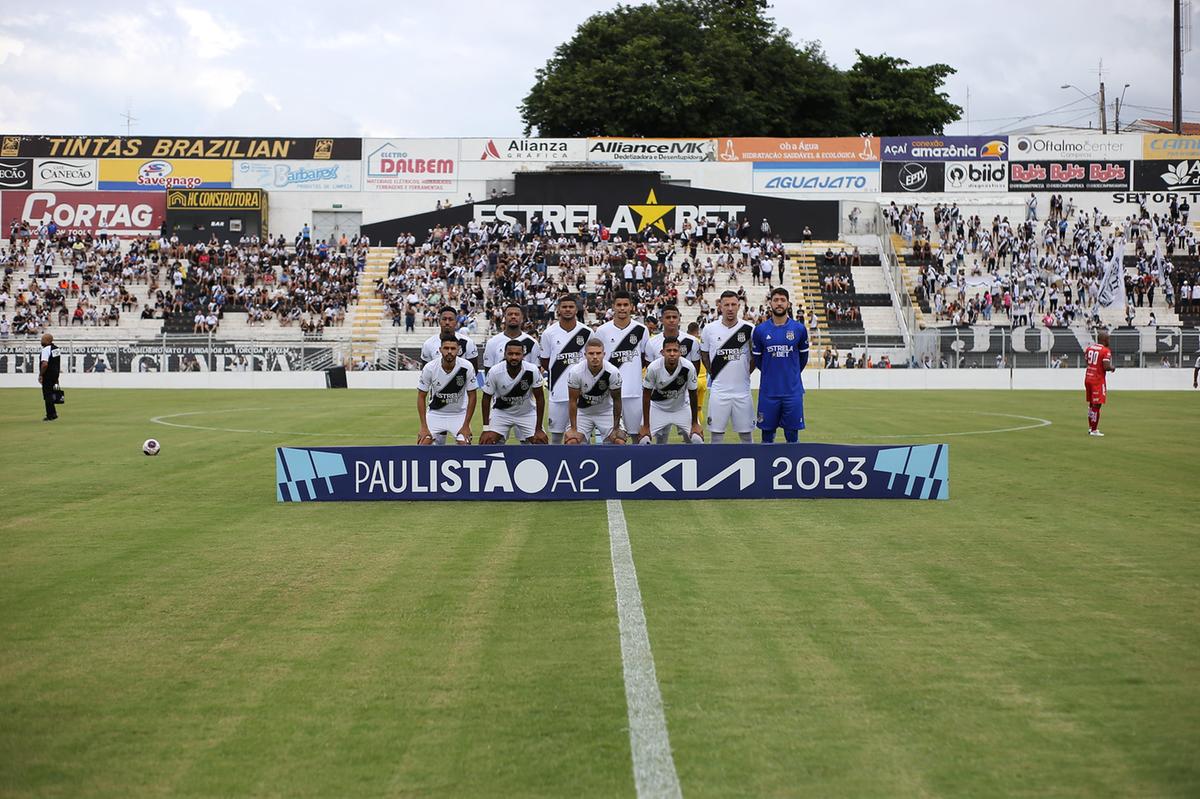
[376,214,784,332]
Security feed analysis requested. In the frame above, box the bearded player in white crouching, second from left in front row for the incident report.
[479,341,550,444]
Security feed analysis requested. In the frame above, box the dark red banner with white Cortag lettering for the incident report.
[0,191,167,236]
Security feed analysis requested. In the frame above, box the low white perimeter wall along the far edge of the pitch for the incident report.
[0,368,1192,388]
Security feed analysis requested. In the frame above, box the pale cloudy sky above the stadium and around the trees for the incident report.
[0,0,1200,137]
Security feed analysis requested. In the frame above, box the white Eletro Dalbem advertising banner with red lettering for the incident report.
[362,139,458,192]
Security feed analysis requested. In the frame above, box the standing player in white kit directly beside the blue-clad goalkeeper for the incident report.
[700,292,755,444]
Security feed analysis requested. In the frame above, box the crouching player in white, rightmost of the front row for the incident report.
[638,336,704,444]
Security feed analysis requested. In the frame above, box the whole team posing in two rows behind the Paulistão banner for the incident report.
[416,287,809,445]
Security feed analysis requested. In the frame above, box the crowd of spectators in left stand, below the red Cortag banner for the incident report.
[0,222,370,335]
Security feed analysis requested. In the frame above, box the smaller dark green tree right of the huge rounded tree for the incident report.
[846,50,962,136]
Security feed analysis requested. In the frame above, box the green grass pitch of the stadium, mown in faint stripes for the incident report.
[0,389,1200,797]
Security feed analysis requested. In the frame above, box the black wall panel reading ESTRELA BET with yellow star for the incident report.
[362,164,840,244]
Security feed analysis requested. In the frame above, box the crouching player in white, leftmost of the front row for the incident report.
[416,332,475,444]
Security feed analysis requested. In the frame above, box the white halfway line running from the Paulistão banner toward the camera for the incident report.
[607,499,683,799]
